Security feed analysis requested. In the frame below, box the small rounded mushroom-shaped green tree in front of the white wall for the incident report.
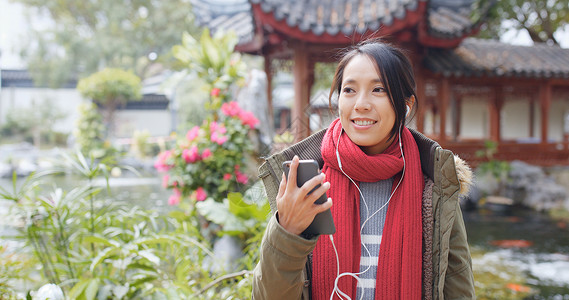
[77,68,142,136]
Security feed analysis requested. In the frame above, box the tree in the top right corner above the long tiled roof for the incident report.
[478,0,569,45]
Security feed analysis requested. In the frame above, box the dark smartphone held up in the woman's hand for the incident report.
[283,160,336,237]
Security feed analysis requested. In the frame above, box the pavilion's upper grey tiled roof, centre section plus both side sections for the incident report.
[190,0,484,44]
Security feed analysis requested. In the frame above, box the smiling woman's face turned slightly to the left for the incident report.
[338,54,395,155]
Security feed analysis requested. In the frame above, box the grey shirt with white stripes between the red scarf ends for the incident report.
[356,178,393,299]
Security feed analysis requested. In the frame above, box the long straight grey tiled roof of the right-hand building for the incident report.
[424,38,569,79]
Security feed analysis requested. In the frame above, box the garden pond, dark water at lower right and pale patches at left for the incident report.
[0,176,569,300]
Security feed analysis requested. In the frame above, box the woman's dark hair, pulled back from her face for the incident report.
[328,39,418,139]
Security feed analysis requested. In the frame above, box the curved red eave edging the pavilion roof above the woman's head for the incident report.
[252,1,427,44]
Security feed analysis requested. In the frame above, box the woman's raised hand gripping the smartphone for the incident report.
[277,156,332,235]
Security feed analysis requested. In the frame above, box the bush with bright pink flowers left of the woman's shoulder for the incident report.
[158,100,259,205]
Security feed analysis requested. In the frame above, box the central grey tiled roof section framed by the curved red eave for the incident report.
[251,0,422,36]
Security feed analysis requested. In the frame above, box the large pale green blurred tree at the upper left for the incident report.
[13,0,198,86]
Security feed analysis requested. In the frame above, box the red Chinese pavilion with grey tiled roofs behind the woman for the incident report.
[194,0,569,165]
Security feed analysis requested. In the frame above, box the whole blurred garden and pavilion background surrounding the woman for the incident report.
[0,0,569,299]
